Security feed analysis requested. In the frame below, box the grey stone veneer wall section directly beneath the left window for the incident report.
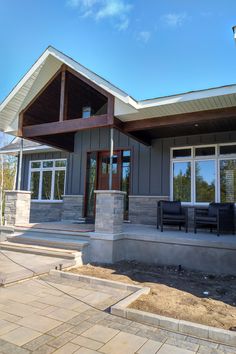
[30,202,63,223]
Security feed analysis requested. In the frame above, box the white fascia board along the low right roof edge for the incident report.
[139,85,236,109]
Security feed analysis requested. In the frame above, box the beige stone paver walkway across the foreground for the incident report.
[0,275,236,354]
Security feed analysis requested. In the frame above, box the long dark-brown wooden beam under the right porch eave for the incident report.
[122,107,236,133]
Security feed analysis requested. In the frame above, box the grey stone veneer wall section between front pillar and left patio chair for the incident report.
[129,195,170,225]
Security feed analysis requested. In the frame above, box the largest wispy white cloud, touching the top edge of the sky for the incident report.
[67,0,132,31]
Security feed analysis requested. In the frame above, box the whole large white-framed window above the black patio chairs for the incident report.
[171,144,236,204]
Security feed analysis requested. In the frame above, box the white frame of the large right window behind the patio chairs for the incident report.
[170,142,236,205]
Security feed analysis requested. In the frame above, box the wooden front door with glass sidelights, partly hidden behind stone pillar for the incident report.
[85,150,131,219]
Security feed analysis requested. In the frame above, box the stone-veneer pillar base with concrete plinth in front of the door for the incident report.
[90,190,125,263]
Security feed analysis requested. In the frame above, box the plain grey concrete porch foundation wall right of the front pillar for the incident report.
[124,240,236,275]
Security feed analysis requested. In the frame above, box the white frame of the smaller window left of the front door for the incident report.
[28,159,67,203]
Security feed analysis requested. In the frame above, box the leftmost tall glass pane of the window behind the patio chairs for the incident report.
[173,162,191,202]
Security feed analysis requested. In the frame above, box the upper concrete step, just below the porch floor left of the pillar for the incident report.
[7,232,89,251]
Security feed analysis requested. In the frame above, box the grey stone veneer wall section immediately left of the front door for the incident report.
[61,195,84,220]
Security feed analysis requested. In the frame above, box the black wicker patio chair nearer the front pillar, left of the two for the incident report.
[157,200,188,232]
